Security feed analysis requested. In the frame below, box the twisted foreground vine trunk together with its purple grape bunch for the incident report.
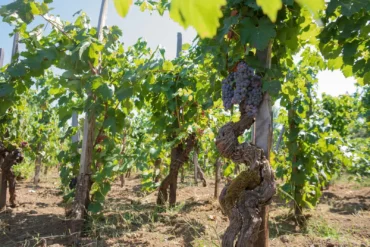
[216,61,275,246]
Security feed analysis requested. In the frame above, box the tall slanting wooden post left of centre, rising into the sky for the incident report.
[71,0,108,234]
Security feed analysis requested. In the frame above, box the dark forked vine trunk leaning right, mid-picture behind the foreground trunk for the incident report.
[157,134,196,206]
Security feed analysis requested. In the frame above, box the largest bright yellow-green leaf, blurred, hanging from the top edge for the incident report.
[170,0,226,38]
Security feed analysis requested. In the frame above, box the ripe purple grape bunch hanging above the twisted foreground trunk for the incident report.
[222,61,262,117]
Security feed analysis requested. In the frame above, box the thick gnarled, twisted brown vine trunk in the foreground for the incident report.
[216,101,276,247]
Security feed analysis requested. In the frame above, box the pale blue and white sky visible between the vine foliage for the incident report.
[0,0,356,96]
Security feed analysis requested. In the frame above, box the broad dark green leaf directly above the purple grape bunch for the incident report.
[240,17,276,50]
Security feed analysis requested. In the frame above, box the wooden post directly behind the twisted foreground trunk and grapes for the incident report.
[253,42,272,247]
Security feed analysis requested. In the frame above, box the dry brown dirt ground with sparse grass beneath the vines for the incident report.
[0,176,370,247]
